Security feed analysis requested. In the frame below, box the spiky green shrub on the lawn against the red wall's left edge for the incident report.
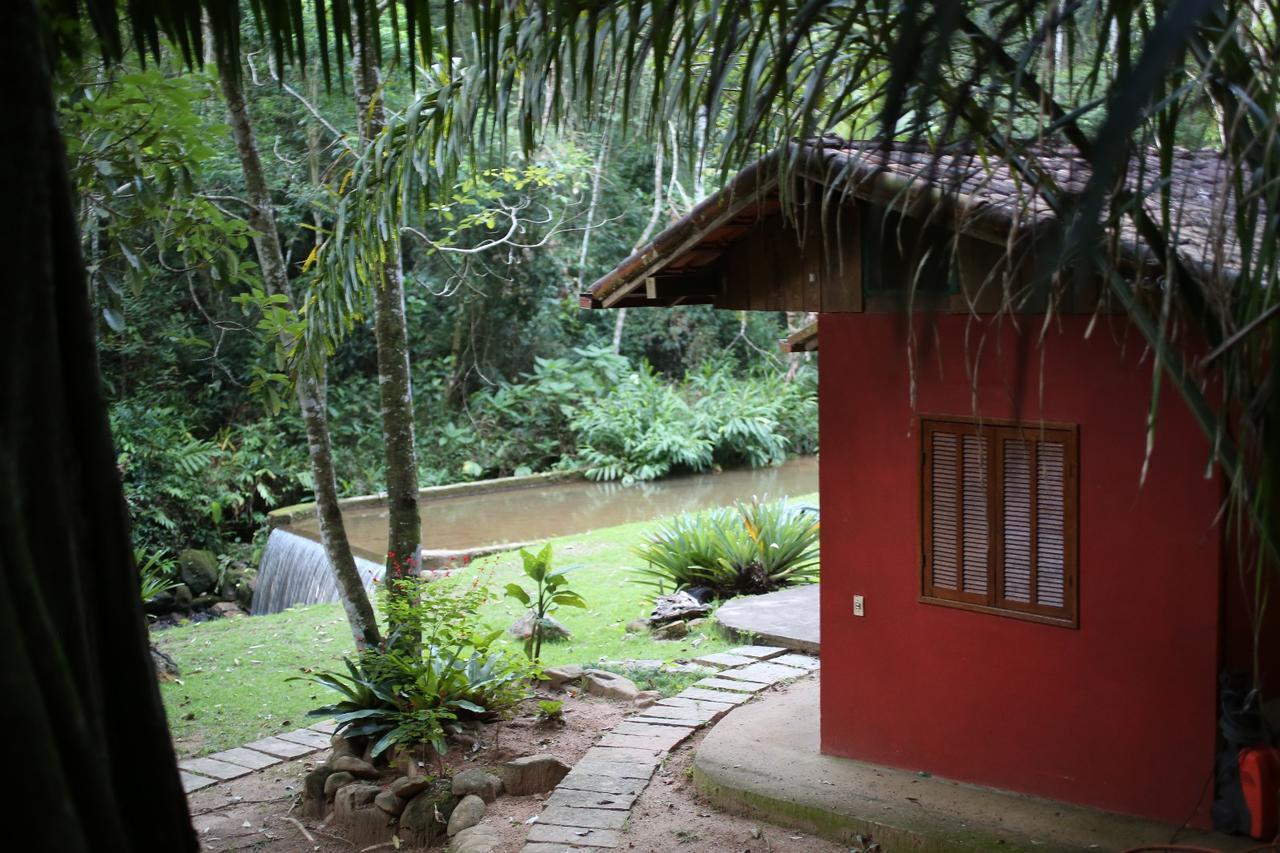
[635,501,818,598]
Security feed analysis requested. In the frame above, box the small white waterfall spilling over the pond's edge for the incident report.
[253,528,383,616]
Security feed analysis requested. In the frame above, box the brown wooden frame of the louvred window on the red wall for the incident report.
[916,415,1080,628]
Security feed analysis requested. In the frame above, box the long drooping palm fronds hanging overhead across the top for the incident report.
[56,0,1280,671]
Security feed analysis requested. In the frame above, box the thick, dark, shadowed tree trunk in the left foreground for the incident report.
[0,0,197,853]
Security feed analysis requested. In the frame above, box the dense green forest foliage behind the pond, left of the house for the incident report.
[59,54,817,556]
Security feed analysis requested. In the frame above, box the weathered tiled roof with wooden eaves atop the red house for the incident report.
[581,137,1240,307]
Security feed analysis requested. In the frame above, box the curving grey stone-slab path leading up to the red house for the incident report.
[521,646,819,853]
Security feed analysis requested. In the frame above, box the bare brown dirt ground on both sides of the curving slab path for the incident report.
[189,676,846,853]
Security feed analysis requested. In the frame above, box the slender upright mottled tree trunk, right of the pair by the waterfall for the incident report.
[352,13,422,630]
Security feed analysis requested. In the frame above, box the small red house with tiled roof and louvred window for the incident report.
[584,145,1280,826]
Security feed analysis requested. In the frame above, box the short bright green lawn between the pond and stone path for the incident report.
[154,496,815,757]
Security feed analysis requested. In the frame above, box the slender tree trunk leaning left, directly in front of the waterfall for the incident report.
[210,38,379,648]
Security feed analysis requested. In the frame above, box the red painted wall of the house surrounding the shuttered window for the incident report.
[819,314,1221,825]
